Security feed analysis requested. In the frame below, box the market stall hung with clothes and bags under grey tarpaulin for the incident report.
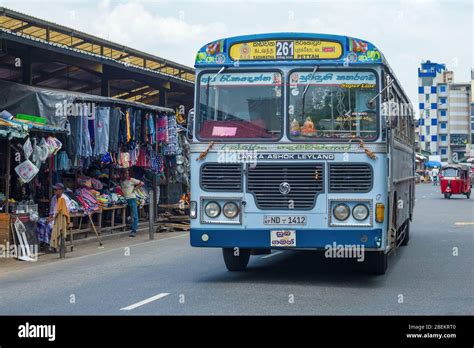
[0,81,189,258]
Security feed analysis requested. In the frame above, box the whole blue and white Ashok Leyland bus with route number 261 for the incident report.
[190,33,415,274]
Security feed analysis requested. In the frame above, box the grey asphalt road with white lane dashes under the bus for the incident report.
[0,184,474,315]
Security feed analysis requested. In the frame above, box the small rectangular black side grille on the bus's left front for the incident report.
[200,163,242,192]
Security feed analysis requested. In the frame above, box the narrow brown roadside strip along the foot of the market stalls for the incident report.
[0,229,187,276]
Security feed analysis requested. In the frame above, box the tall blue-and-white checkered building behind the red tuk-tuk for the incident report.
[418,61,474,163]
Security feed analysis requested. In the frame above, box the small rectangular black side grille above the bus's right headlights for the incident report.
[329,163,373,193]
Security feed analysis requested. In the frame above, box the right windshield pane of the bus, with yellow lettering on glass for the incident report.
[288,71,378,140]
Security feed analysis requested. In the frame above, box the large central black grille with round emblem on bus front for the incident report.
[247,163,324,210]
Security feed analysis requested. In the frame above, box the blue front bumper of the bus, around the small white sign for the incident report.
[190,228,383,249]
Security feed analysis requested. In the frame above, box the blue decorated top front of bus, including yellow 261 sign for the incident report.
[195,33,386,68]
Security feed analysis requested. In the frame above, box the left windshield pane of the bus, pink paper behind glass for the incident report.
[196,72,283,140]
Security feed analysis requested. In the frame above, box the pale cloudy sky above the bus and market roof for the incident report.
[0,0,474,109]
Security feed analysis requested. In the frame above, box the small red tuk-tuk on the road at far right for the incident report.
[440,164,471,199]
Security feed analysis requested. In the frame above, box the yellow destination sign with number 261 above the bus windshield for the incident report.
[229,39,342,61]
